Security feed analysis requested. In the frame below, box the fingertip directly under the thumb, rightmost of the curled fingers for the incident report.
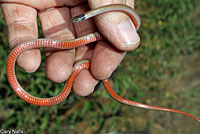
[91,41,126,80]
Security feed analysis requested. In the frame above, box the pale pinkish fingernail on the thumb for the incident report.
[117,20,140,47]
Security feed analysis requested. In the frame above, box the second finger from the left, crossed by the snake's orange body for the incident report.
[39,7,75,83]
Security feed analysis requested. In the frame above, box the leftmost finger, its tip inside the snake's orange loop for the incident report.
[1,3,41,72]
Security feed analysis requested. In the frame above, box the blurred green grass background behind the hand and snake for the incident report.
[0,0,200,134]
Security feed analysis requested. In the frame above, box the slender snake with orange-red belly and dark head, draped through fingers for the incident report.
[7,4,200,122]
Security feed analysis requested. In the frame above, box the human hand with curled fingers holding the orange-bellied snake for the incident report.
[1,0,140,96]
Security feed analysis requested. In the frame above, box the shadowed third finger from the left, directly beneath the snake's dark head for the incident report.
[71,4,98,96]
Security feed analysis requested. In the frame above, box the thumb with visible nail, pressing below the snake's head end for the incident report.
[88,0,140,51]
